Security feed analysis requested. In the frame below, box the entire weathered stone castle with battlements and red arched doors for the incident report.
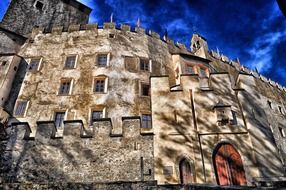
[0,0,286,187]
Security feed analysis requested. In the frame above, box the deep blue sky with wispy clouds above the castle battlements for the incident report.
[0,0,286,86]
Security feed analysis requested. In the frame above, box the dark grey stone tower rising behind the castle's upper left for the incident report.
[0,0,91,35]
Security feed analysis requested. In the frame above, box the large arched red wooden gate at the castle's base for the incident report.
[214,144,246,185]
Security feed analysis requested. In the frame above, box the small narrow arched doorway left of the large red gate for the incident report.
[179,158,193,184]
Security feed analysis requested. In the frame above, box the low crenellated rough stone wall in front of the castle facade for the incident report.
[0,119,154,183]
